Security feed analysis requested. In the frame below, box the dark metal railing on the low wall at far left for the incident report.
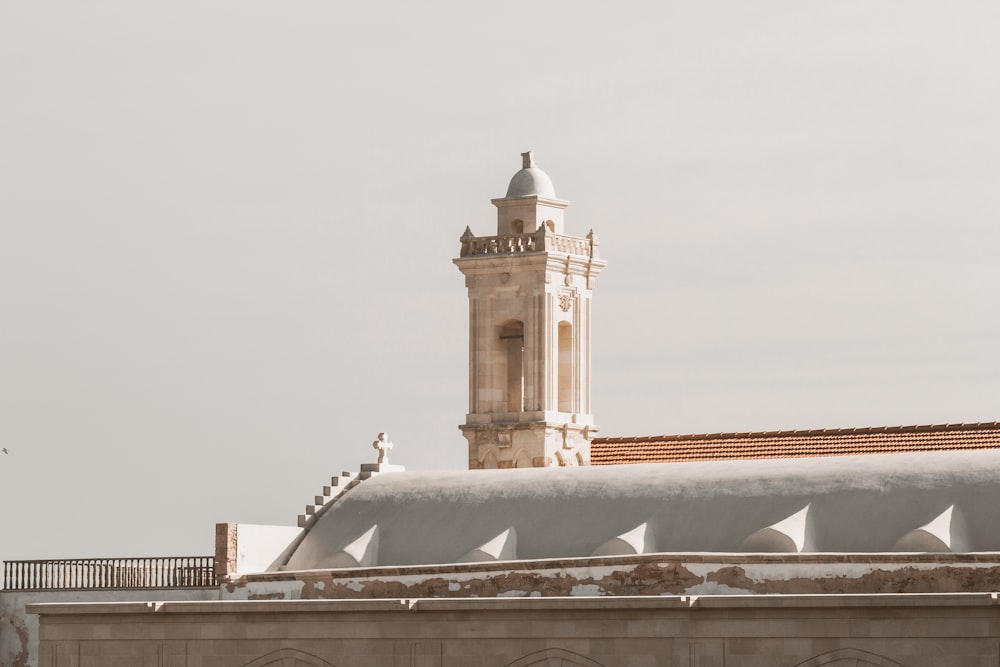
[3,556,216,591]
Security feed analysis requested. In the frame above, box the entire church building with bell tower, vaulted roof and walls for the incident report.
[7,153,1000,667]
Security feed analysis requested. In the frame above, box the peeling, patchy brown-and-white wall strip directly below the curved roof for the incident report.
[222,554,1000,600]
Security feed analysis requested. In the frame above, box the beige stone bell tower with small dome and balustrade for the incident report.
[454,152,606,469]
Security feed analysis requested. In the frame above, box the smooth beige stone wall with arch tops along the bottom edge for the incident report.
[31,594,1000,667]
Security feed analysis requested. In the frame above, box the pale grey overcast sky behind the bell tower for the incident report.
[0,0,1000,560]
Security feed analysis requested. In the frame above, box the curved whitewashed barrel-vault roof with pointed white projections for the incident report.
[285,450,1000,569]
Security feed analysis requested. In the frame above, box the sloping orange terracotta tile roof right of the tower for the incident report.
[590,422,1000,465]
